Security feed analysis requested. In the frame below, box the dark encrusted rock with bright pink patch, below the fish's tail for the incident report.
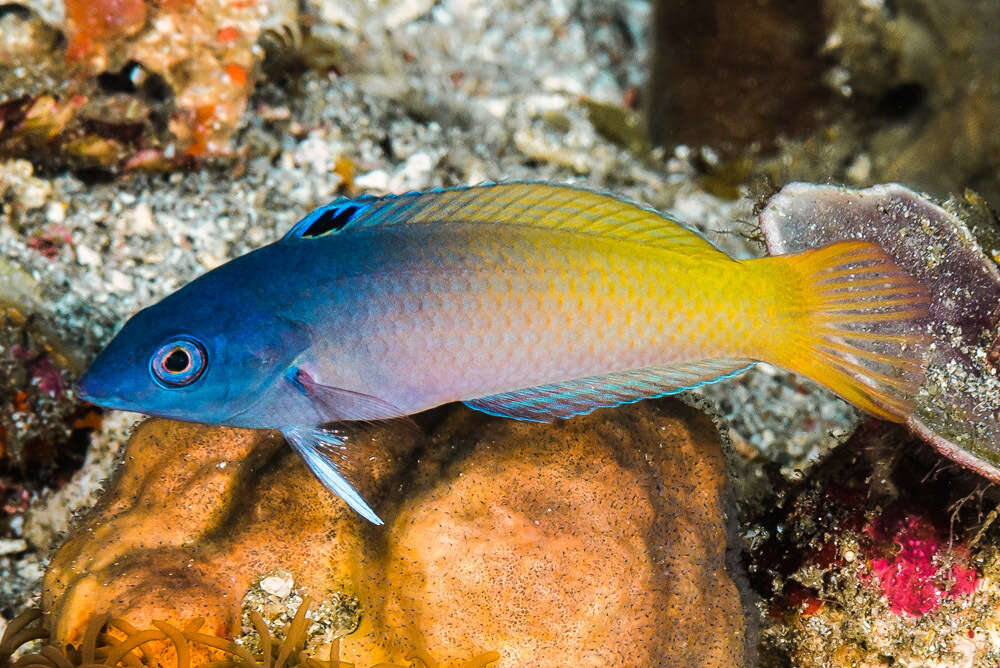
[747,421,1000,668]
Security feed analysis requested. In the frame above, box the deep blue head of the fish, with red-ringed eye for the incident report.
[77,281,308,424]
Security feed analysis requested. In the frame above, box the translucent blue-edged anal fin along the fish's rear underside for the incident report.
[465,358,755,422]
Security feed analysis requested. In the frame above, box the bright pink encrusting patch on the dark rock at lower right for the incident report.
[866,514,980,617]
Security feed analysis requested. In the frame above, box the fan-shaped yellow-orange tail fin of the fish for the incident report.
[759,241,929,422]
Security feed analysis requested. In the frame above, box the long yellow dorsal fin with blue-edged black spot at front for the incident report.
[285,182,711,247]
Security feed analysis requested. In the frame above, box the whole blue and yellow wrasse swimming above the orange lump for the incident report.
[78,183,927,524]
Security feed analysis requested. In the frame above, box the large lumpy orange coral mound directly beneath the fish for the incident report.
[44,401,747,666]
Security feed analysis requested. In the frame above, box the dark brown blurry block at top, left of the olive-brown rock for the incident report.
[647,0,837,157]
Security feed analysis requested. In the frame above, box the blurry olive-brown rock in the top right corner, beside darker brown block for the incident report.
[831,0,1000,198]
